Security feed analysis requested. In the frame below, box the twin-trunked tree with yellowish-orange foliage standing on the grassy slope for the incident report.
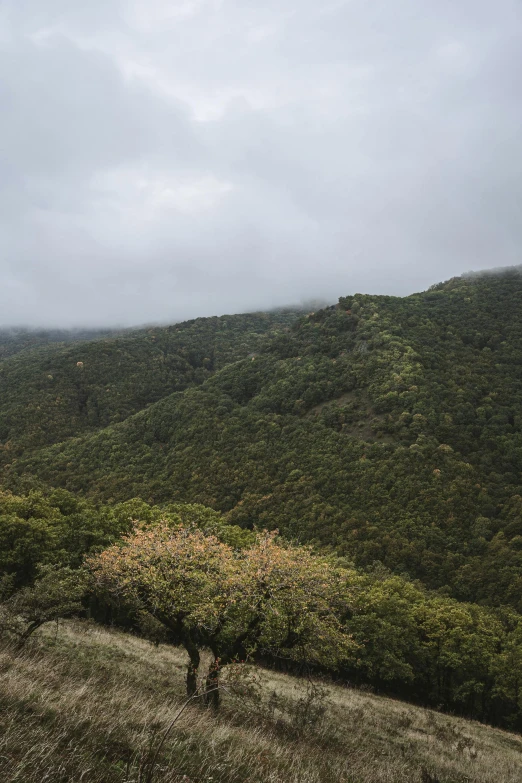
[88,524,355,706]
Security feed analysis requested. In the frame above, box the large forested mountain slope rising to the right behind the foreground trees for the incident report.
[6,269,522,610]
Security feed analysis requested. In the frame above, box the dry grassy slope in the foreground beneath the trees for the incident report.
[0,623,522,783]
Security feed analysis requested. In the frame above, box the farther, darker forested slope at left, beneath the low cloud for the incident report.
[0,311,298,458]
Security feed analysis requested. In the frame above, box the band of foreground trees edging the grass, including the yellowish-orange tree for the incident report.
[0,490,522,728]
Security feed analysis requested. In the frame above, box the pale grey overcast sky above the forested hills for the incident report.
[0,0,522,326]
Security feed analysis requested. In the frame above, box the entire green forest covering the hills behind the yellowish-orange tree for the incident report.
[0,268,522,726]
